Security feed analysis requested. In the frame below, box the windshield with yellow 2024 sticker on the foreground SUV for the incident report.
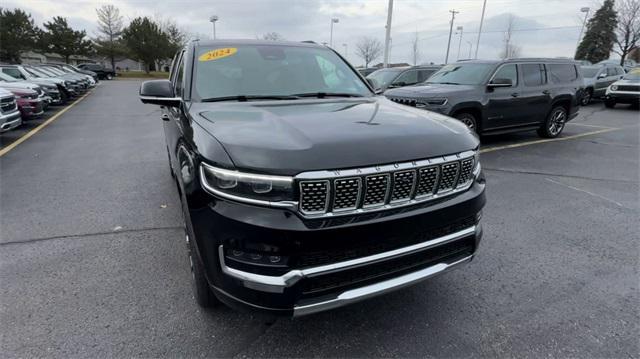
[193,45,371,100]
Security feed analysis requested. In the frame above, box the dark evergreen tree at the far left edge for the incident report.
[0,8,40,63]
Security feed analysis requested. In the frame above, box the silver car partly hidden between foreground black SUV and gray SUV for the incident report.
[367,66,442,91]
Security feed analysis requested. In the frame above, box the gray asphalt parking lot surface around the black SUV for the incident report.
[0,81,640,358]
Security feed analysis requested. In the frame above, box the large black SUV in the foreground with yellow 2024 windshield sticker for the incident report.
[140,40,485,315]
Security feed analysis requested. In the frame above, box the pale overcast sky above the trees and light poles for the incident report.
[8,0,600,65]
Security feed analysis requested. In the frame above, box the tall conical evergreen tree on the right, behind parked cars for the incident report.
[575,0,618,64]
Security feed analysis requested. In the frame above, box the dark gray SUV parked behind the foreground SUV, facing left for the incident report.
[385,59,584,137]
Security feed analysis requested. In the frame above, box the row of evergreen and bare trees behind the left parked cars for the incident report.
[0,5,188,72]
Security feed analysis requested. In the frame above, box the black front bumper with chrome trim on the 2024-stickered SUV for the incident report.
[188,176,485,316]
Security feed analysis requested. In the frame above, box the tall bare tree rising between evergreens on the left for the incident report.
[94,5,126,70]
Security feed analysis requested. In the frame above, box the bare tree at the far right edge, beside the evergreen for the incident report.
[613,0,640,66]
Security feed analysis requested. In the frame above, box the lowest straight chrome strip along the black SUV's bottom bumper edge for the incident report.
[293,255,473,317]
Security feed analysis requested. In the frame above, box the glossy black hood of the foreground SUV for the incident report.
[189,96,479,175]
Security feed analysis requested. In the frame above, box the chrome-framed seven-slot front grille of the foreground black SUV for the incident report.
[296,151,476,218]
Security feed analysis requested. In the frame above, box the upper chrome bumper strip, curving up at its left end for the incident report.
[218,226,477,293]
